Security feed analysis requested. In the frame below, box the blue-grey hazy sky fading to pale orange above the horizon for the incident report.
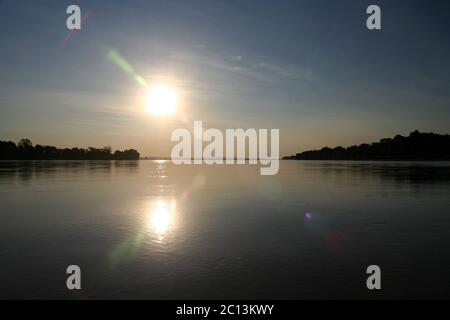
[0,0,450,156]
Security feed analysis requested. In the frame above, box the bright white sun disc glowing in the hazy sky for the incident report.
[146,85,177,116]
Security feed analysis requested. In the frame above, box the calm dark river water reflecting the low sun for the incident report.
[0,161,450,299]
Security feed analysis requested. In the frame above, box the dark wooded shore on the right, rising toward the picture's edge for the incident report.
[283,130,450,160]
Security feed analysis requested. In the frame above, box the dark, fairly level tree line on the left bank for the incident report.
[0,139,139,160]
